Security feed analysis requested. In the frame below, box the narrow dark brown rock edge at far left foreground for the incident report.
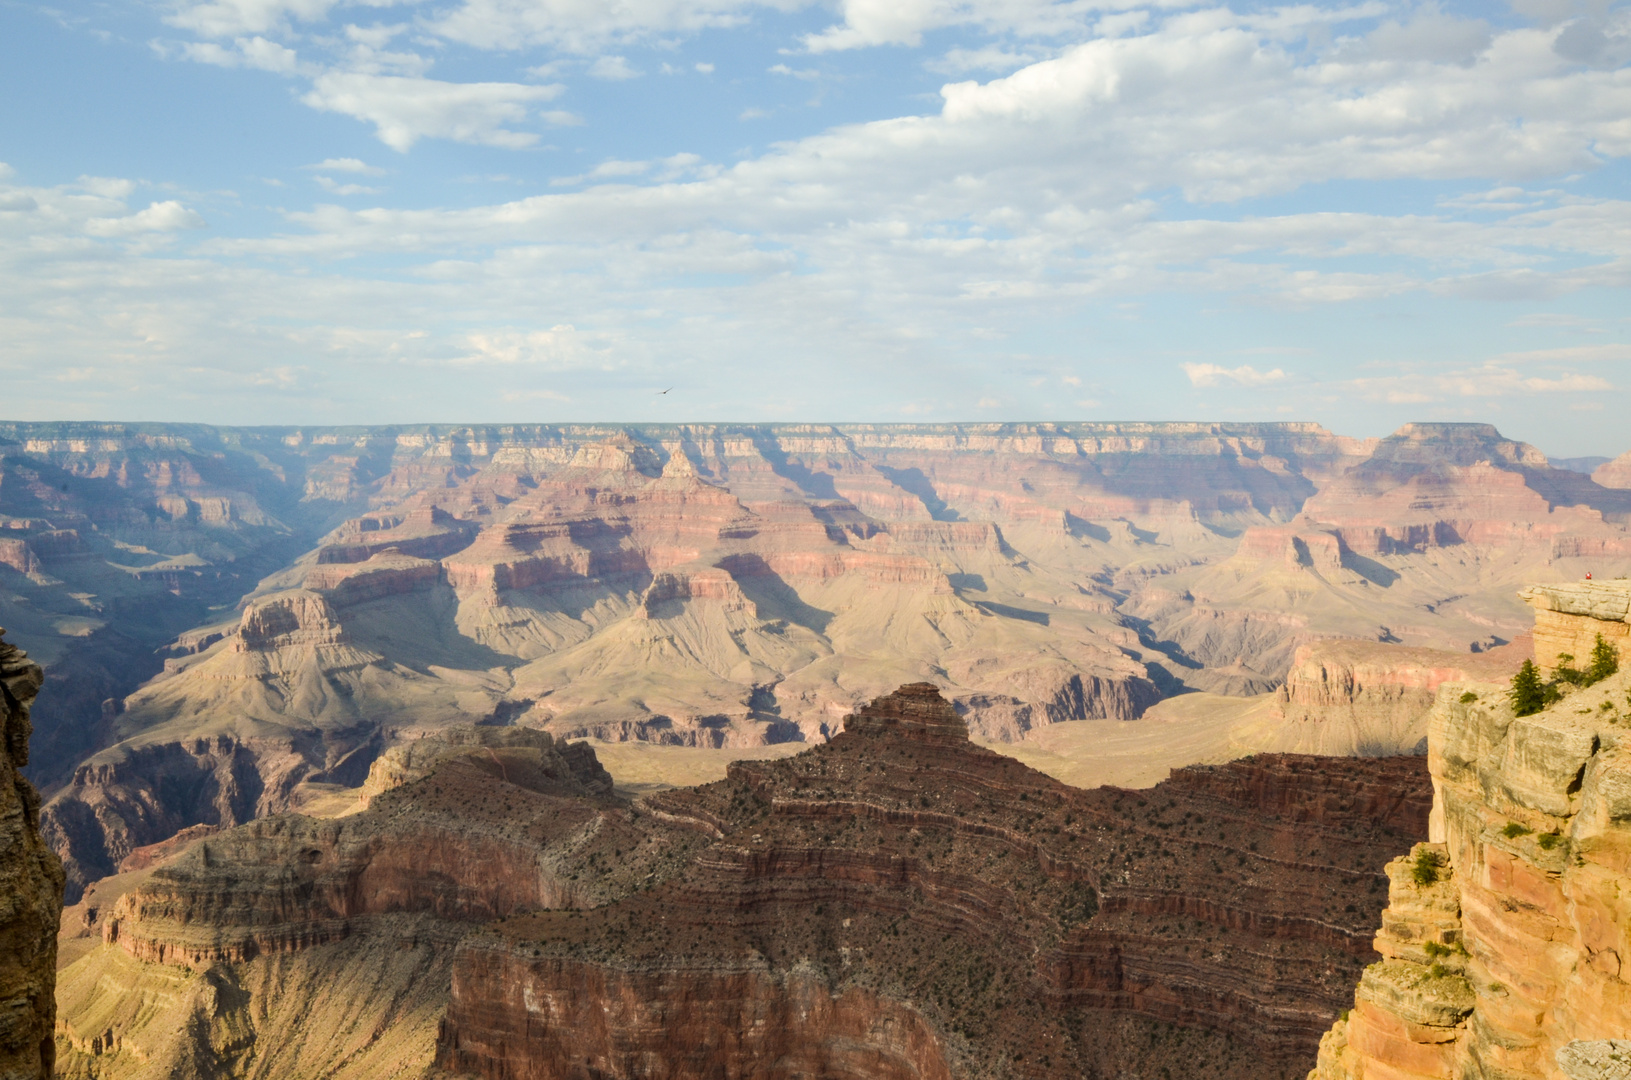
[0,630,62,1080]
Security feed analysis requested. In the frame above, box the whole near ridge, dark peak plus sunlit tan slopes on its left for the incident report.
[59,684,1430,1080]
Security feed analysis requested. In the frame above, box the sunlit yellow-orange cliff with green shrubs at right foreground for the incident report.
[1313,587,1631,1080]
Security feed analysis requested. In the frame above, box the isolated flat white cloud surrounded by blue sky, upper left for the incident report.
[302,72,561,153]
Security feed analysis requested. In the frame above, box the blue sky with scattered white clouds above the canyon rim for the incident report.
[0,0,1631,455]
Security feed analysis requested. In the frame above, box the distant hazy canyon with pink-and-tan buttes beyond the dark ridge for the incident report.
[12,424,1631,901]
